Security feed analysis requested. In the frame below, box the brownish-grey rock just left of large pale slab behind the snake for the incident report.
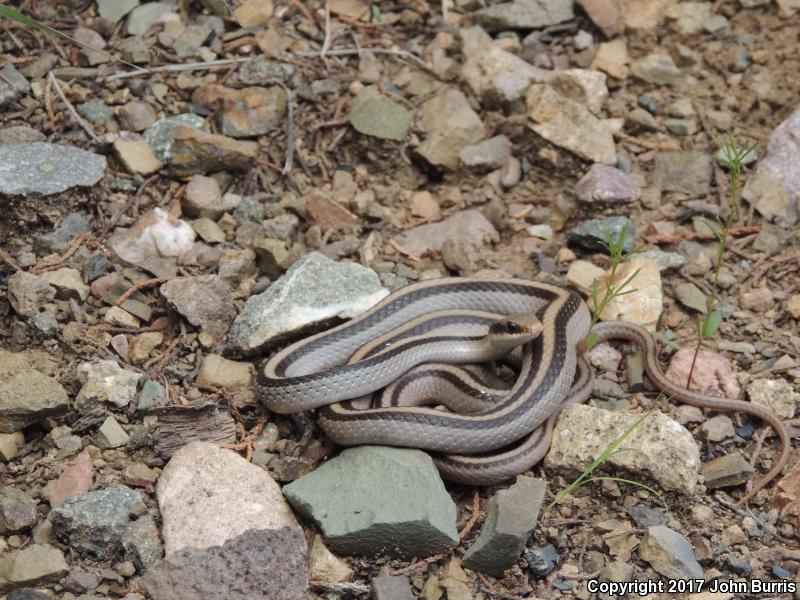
[160,275,236,346]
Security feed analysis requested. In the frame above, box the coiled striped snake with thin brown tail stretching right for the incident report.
[256,278,791,504]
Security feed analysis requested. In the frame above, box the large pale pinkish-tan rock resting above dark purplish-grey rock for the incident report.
[156,442,299,555]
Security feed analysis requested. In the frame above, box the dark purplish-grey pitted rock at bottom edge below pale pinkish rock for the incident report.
[142,527,309,600]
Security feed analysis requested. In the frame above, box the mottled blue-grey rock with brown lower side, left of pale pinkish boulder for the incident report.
[49,485,154,560]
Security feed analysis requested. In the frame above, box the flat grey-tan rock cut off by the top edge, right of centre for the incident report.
[474,0,575,30]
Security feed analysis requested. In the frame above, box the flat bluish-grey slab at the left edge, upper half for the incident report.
[0,142,106,196]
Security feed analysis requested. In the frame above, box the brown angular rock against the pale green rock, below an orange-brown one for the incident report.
[167,125,258,175]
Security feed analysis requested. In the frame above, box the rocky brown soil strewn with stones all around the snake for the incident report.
[0,0,800,600]
